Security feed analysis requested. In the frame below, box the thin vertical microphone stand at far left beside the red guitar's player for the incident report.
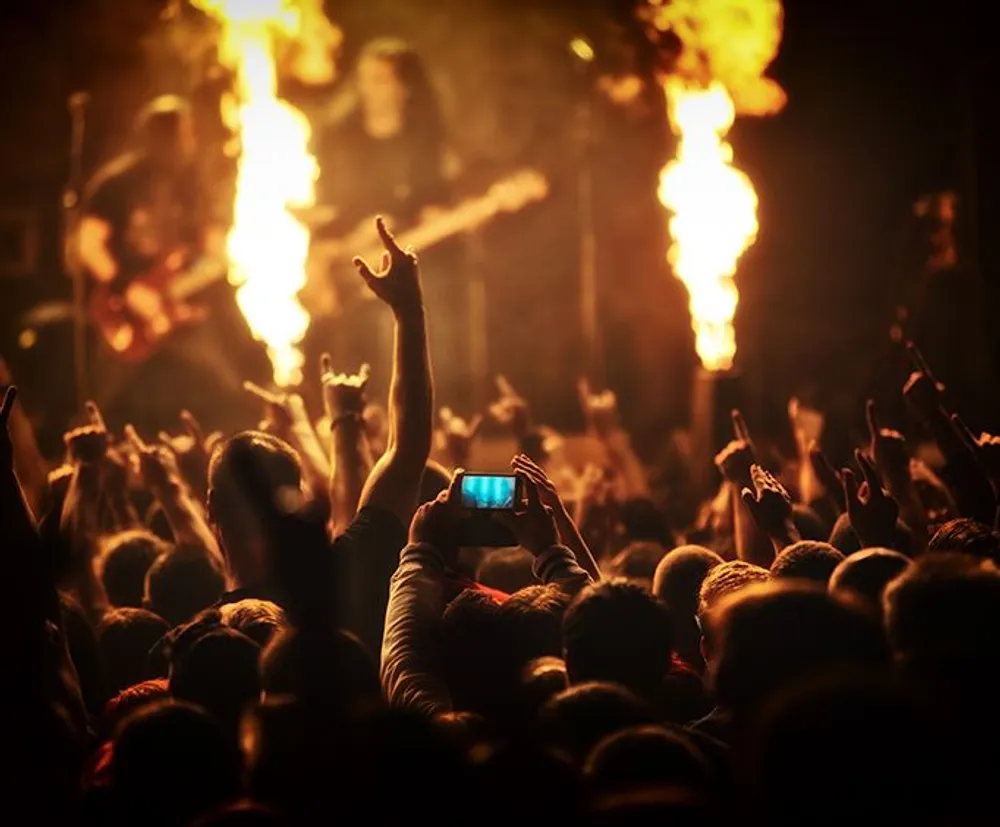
[62,92,90,409]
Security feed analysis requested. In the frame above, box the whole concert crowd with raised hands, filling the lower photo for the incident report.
[0,217,1000,827]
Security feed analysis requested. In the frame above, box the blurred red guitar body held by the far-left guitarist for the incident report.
[87,253,213,363]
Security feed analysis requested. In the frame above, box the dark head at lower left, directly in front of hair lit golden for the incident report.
[170,626,260,733]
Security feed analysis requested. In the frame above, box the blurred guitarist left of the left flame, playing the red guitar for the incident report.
[78,96,254,434]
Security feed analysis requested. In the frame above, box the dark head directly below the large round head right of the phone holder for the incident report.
[539,683,657,765]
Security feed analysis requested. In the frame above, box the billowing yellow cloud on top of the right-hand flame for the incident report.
[639,0,786,116]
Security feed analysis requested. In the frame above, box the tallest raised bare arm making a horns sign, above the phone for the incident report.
[354,213,433,525]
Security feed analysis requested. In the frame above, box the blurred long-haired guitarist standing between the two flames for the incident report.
[312,38,469,404]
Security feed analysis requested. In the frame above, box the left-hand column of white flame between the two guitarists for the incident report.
[194,0,340,386]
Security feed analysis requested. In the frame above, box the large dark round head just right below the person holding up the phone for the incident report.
[563,580,673,700]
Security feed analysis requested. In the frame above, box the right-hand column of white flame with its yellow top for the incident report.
[642,0,785,371]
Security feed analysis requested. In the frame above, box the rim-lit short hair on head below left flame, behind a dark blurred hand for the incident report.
[208,431,302,533]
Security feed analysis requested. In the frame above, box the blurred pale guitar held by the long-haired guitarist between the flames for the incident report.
[302,169,549,315]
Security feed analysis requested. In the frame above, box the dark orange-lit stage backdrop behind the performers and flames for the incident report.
[0,0,998,456]
